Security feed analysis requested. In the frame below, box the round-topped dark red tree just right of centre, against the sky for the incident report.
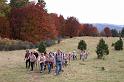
[65,17,80,38]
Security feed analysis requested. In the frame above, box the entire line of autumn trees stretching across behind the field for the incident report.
[0,0,124,43]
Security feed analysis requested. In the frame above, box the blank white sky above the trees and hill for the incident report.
[7,0,124,25]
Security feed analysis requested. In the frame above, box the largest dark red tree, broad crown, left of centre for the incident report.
[10,3,54,43]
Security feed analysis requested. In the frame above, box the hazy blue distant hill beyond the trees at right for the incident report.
[93,23,124,31]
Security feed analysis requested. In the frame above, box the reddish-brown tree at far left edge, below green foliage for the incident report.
[0,17,11,38]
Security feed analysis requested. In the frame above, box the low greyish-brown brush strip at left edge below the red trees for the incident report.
[0,39,35,51]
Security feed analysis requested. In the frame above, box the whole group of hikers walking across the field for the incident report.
[24,50,88,75]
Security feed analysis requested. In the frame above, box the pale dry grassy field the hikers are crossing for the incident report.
[0,37,124,82]
